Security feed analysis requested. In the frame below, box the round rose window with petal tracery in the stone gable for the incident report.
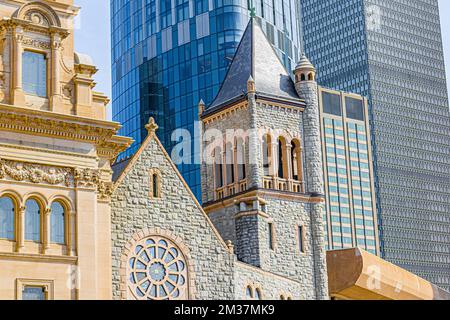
[129,237,187,300]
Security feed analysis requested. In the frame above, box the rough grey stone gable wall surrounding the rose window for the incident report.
[111,139,234,299]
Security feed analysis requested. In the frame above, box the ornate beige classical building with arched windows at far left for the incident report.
[0,0,131,299]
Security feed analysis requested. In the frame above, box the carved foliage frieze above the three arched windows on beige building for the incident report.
[0,159,73,187]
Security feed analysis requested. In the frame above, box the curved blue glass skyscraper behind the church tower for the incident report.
[111,0,301,198]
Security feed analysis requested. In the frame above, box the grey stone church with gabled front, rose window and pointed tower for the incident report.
[111,19,328,300]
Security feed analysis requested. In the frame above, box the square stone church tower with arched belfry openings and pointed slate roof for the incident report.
[199,19,328,299]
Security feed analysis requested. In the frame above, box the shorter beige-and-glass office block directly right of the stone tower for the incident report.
[319,88,379,254]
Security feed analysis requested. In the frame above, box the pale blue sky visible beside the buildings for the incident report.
[75,0,450,119]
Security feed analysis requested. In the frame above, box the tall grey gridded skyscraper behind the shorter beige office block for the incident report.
[301,0,450,289]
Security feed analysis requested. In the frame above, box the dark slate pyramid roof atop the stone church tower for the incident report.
[206,18,300,110]
